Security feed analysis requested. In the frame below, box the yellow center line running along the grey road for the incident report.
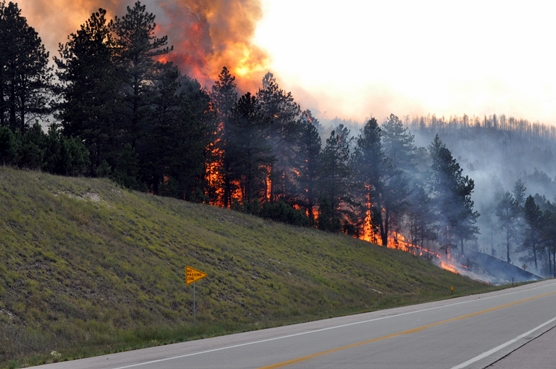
[258,291,556,369]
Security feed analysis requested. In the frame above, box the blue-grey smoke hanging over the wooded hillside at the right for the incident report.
[406,115,556,275]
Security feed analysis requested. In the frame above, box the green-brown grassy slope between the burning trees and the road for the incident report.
[0,167,496,367]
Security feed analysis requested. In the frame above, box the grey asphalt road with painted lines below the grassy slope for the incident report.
[32,280,556,369]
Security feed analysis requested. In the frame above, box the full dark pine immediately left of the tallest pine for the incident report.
[54,9,121,174]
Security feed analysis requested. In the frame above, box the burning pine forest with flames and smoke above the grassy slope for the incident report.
[0,2,556,276]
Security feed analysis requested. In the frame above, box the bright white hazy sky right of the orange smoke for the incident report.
[256,0,556,124]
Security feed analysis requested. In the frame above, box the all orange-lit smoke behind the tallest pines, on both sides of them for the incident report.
[20,0,268,91]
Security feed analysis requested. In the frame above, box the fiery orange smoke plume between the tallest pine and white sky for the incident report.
[159,0,269,91]
